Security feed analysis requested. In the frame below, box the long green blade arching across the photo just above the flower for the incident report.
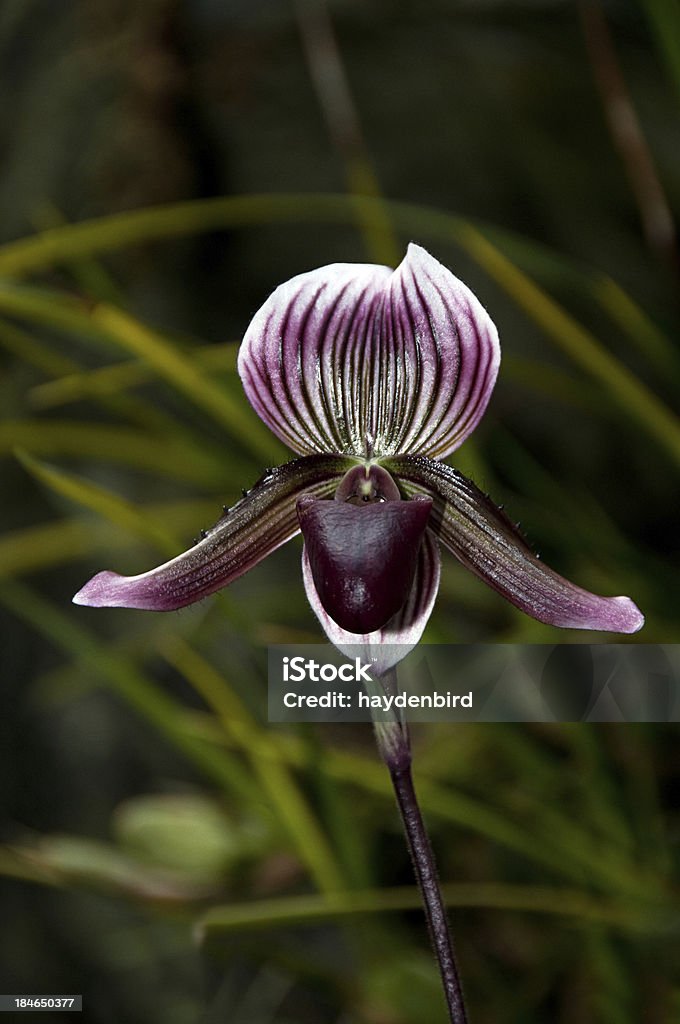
[0,194,680,462]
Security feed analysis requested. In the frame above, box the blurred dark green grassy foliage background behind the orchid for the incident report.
[0,0,680,1024]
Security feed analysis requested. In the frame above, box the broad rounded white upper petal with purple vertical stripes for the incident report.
[239,245,500,458]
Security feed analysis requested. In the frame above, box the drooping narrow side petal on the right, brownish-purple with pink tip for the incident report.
[384,456,644,633]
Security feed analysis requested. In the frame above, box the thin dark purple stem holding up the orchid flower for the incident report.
[374,670,467,1024]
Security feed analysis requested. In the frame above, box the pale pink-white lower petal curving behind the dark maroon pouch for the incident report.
[302,530,441,676]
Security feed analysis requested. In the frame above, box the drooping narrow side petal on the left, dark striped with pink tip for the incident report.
[73,455,352,611]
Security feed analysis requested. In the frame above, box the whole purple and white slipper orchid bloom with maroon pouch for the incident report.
[74,245,644,669]
